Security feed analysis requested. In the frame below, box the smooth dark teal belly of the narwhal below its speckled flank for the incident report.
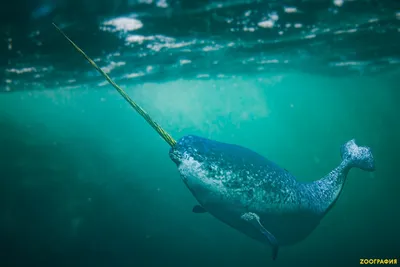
[183,169,321,246]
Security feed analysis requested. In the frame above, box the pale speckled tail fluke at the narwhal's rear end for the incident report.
[340,139,375,172]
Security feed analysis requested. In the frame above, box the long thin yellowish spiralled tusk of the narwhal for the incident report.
[53,23,176,147]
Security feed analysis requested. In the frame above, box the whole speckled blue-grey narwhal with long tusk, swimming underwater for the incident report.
[54,24,375,260]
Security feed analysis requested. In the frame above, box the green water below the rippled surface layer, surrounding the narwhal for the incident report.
[0,72,400,267]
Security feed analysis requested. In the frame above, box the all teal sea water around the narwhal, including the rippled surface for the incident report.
[0,0,400,267]
